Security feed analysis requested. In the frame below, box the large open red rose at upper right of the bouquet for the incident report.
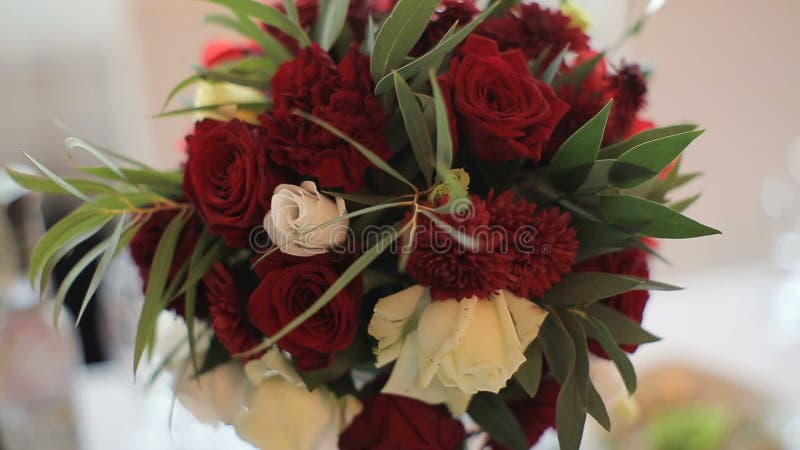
[440,36,569,162]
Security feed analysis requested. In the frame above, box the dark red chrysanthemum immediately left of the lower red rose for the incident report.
[203,262,262,359]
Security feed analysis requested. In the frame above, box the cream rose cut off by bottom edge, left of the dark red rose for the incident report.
[235,349,361,450]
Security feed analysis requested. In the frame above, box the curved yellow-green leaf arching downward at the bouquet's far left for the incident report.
[30,210,111,287]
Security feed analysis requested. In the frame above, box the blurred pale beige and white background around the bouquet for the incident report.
[0,0,800,450]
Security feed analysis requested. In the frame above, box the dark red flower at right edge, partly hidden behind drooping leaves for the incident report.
[575,248,650,358]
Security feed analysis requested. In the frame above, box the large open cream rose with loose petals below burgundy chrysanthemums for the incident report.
[369,286,547,414]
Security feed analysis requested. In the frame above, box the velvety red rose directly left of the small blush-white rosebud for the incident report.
[183,119,287,248]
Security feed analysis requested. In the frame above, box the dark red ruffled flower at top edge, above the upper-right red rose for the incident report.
[476,3,589,65]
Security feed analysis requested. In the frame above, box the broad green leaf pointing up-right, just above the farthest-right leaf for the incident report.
[609,130,703,188]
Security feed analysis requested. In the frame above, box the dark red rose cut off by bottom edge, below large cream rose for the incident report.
[339,394,466,450]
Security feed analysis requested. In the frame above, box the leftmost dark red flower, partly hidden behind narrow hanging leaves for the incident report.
[128,209,208,317]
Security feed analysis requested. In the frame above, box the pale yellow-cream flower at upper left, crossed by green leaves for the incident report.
[194,81,267,125]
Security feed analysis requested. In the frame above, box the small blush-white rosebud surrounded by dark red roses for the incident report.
[264,181,349,256]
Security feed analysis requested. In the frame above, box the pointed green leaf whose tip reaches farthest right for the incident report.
[599,195,720,239]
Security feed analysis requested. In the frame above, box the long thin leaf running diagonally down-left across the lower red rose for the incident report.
[240,225,409,356]
